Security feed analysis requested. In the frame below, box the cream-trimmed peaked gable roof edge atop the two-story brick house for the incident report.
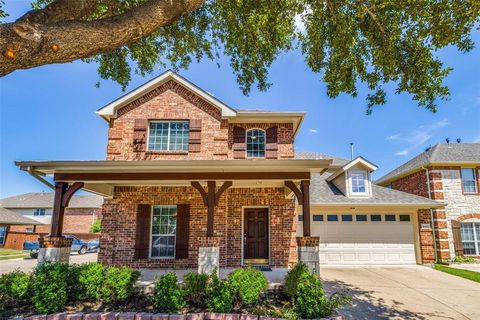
[95,70,237,121]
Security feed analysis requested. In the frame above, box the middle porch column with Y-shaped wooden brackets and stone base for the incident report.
[191,181,232,275]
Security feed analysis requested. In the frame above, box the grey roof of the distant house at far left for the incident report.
[0,192,103,209]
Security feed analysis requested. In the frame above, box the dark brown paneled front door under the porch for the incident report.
[243,208,269,264]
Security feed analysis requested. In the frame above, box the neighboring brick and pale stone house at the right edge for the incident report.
[377,143,480,260]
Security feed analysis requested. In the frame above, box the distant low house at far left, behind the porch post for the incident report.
[0,192,103,233]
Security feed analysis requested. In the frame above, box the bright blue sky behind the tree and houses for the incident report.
[0,1,480,197]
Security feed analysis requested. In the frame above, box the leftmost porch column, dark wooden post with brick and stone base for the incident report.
[38,182,83,263]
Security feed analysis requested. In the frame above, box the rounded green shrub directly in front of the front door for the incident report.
[228,268,268,305]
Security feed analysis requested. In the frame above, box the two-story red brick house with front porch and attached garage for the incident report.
[16,71,443,271]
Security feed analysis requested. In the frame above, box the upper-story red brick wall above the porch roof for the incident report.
[107,81,293,160]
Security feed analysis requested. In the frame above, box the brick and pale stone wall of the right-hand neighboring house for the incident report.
[391,166,480,260]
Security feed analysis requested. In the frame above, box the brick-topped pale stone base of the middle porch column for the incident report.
[197,237,221,275]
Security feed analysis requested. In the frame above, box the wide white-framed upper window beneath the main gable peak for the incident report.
[148,121,189,151]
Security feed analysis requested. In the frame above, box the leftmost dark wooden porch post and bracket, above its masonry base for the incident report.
[50,182,83,237]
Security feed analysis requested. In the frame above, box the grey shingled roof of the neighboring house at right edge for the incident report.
[376,143,480,185]
